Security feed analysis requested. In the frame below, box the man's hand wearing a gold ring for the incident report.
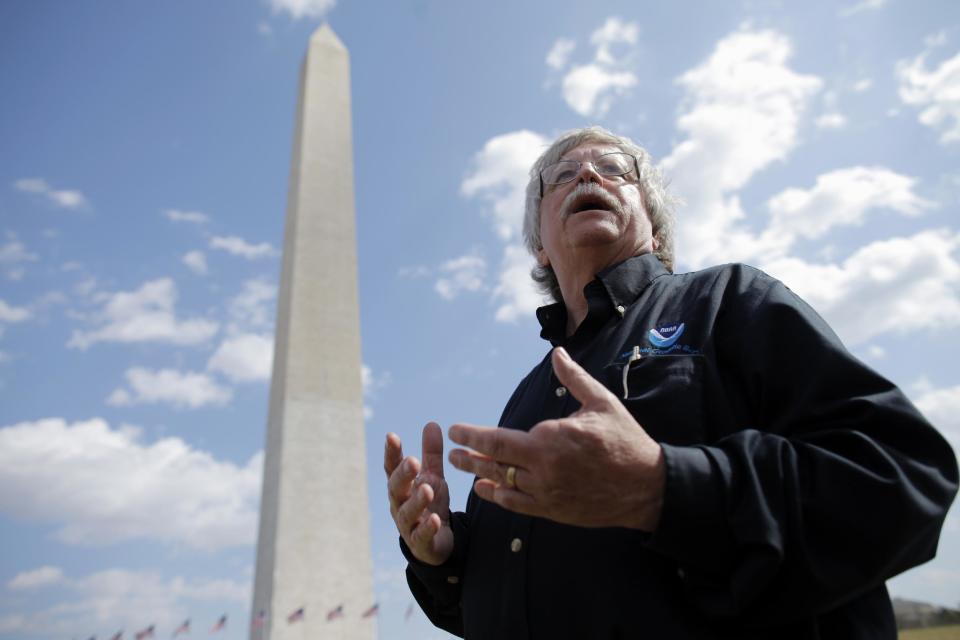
[449,347,665,531]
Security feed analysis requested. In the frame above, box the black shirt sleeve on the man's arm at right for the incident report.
[650,279,957,624]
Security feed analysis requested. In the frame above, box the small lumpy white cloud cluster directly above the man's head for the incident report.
[547,17,639,117]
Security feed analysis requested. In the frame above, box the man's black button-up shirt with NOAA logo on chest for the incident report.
[401,255,957,640]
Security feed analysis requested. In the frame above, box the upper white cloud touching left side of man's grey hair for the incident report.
[460,129,549,241]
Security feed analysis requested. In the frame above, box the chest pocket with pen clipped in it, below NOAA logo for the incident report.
[604,355,706,446]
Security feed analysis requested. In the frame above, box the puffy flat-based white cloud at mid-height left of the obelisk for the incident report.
[67,278,219,349]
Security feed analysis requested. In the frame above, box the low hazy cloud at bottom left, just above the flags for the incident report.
[0,567,251,637]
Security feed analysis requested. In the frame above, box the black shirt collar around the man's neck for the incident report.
[537,253,669,346]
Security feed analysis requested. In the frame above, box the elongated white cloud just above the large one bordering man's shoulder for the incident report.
[764,166,936,249]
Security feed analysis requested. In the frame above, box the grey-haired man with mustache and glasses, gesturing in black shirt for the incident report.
[384,128,957,640]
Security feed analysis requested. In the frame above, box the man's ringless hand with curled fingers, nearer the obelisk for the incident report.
[383,422,453,565]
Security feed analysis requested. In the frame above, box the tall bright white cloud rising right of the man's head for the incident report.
[663,28,823,268]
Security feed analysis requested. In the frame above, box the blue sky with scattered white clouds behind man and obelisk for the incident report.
[0,0,960,640]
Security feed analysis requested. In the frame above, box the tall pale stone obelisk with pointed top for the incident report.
[250,25,375,640]
